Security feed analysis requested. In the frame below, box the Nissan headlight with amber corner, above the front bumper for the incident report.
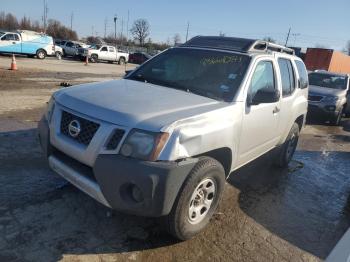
[120,129,169,161]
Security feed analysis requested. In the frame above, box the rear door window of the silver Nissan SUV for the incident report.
[278,58,295,97]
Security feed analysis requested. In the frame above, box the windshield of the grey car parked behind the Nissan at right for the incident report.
[309,73,347,89]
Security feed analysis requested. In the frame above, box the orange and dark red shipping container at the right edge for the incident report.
[304,48,350,74]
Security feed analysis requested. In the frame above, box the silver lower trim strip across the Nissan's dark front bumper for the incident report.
[49,156,111,208]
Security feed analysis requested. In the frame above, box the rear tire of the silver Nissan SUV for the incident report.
[275,123,300,168]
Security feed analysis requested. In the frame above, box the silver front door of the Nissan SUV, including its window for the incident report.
[238,60,280,165]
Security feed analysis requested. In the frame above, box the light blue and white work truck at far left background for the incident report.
[0,30,55,59]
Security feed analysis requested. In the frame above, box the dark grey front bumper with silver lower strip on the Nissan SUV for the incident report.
[38,117,197,217]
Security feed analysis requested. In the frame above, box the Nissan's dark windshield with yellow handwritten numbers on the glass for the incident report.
[126,48,250,102]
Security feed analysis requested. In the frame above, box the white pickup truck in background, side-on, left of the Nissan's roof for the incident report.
[78,45,129,65]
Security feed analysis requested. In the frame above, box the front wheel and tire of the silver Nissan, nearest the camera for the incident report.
[163,157,225,240]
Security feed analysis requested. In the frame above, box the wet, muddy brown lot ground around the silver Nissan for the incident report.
[0,64,350,261]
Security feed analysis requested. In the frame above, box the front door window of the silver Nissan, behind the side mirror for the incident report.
[249,61,275,97]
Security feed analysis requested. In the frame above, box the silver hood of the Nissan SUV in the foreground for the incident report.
[54,79,227,131]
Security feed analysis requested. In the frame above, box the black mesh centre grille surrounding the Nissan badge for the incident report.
[61,111,100,145]
